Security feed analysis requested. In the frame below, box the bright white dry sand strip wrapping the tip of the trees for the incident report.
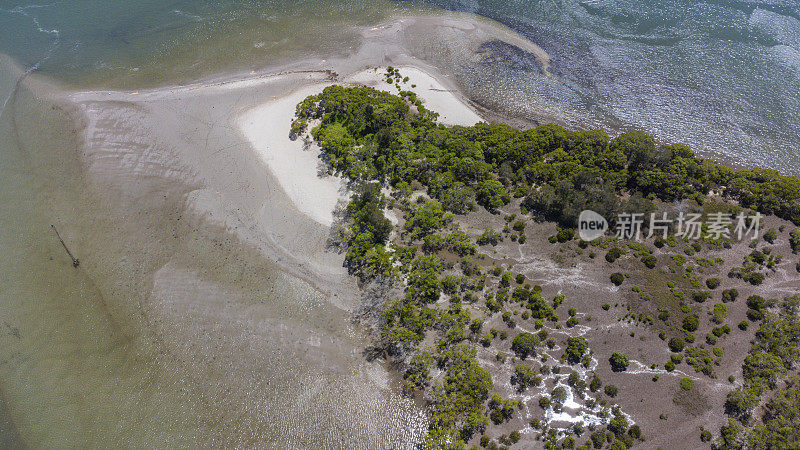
[236,67,482,226]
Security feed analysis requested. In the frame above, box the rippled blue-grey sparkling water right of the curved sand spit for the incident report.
[416,0,800,174]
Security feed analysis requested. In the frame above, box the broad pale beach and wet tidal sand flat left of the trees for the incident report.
[4,14,548,448]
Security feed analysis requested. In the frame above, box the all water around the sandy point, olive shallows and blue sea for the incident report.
[0,0,800,447]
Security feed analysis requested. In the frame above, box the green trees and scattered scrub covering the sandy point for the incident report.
[292,72,800,448]
